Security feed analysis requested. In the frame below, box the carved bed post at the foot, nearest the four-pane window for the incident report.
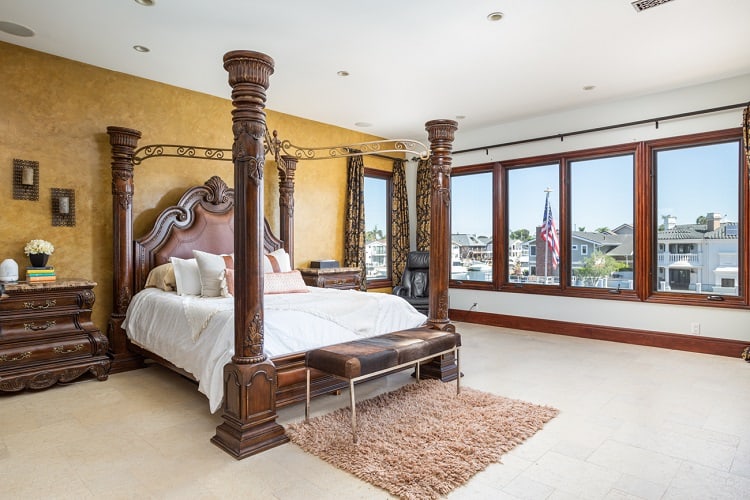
[422,120,458,382]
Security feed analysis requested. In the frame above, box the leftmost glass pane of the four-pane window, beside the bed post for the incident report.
[451,172,493,281]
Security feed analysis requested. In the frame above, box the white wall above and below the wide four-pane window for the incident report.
[444,75,750,341]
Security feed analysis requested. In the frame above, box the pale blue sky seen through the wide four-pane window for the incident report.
[451,142,739,235]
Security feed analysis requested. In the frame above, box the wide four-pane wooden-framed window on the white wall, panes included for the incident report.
[451,128,750,307]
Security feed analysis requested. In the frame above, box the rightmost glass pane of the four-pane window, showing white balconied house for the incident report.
[653,141,742,295]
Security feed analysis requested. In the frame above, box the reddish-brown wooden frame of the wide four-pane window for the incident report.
[450,128,750,308]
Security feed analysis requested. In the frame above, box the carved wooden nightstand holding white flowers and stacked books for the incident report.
[0,279,110,391]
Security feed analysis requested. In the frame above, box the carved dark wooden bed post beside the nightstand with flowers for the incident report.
[107,127,143,373]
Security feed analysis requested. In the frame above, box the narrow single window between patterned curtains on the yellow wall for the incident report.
[365,168,392,288]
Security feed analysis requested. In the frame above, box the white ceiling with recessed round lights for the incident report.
[0,0,750,139]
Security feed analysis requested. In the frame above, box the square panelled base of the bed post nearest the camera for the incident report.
[211,361,289,460]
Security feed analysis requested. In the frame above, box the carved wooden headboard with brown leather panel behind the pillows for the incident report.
[133,176,283,292]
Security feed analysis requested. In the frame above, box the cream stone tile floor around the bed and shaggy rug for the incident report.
[0,324,750,500]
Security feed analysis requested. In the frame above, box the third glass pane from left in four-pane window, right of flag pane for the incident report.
[570,154,635,289]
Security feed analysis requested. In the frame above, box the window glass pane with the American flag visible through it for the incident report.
[506,163,560,285]
